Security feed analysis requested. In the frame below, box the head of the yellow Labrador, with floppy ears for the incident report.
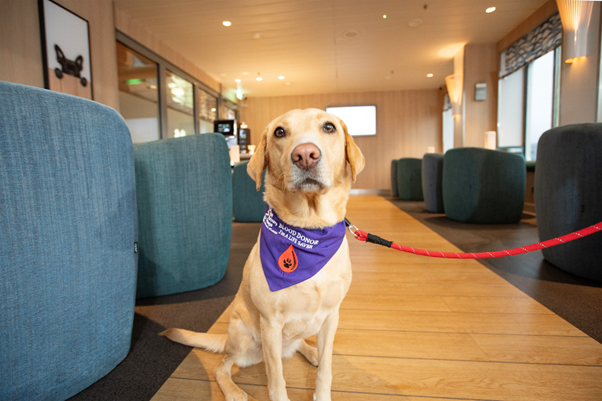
[247,109,364,194]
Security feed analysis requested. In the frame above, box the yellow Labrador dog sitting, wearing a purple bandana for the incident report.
[161,109,364,401]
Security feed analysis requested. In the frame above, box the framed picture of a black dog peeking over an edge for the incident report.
[38,0,92,100]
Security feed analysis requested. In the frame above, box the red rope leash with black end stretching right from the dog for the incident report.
[345,219,602,259]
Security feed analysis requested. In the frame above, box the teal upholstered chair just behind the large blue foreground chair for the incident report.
[134,134,232,298]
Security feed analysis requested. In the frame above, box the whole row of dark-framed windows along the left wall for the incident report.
[117,32,221,143]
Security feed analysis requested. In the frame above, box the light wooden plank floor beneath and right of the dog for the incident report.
[153,195,602,401]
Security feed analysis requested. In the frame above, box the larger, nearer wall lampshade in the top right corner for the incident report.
[556,0,594,63]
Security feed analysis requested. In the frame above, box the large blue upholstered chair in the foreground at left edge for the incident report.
[0,82,137,400]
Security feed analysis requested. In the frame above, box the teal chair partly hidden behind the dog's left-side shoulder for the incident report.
[232,160,267,222]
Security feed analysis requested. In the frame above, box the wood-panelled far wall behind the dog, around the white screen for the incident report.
[243,89,443,189]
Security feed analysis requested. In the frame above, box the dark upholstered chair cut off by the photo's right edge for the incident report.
[535,124,602,281]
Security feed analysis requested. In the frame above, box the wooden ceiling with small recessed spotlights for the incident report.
[114,0,546,97]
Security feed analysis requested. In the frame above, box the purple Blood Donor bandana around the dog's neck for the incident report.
[259,207,345,291]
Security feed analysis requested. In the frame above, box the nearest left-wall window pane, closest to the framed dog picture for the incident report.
[117,42,161,143]
